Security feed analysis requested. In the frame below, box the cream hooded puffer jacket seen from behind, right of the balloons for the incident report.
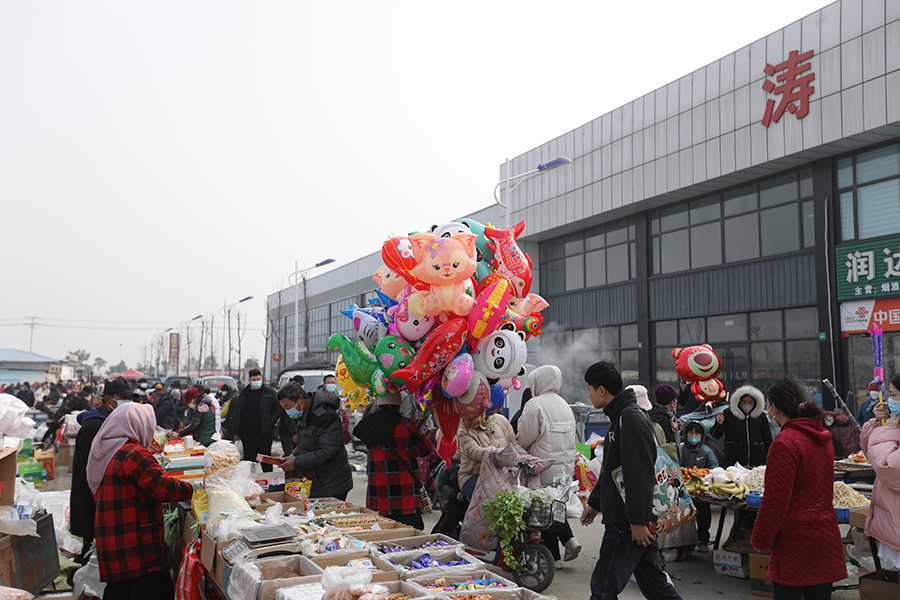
[519,365,576,486]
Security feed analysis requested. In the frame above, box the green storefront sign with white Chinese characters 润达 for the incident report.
[834,238,900,300]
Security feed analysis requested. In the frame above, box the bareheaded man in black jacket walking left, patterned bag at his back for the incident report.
[581,360,681,600]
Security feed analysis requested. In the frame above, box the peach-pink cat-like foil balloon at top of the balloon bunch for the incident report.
[409,233,477,317]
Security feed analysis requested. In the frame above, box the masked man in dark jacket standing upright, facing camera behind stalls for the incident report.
[225,369,283,473]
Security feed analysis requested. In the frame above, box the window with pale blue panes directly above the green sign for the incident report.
[837,144,900,242]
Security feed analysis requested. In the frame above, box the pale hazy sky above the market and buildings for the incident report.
[0,0,827,376]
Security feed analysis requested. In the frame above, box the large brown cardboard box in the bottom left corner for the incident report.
[0,510,60,594]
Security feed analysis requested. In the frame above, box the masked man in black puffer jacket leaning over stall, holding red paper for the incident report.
[278,381,353,500]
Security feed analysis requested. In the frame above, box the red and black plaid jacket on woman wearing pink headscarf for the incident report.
[96,441,193,581]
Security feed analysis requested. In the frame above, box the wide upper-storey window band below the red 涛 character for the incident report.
[650,169,815,275]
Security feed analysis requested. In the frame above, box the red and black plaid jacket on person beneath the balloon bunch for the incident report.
[366,417,431,515]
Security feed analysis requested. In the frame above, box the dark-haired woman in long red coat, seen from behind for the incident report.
[750,377,847,600]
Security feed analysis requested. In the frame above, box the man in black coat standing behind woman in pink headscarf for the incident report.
[69,377,134,557]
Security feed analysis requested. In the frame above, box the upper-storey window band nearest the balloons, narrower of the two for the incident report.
[541,219,636,295]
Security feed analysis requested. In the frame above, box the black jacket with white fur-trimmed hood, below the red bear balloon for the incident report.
[710,385,772,468]
